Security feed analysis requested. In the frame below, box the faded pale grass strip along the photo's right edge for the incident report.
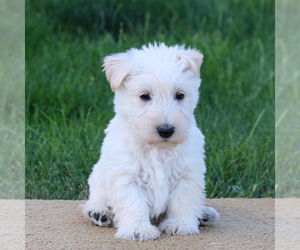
[275,0,300,198]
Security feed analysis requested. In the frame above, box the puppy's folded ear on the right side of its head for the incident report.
[177,49,203,76]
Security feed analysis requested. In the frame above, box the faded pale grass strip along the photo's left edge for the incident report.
[0,1,25,199]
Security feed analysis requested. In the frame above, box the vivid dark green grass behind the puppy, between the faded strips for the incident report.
[25,0,275,199]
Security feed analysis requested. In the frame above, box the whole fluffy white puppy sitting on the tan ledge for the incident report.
[83,43,219,241]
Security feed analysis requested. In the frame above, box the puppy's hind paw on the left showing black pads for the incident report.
[82,203,114,227]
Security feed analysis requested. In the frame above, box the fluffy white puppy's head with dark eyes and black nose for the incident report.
[103,43,203,149]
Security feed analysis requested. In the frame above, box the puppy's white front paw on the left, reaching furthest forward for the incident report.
[115,223,160,241]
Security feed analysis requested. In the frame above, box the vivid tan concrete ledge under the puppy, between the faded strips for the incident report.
[26,198,275,249]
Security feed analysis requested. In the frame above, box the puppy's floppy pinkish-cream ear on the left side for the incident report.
[103,53,131,91]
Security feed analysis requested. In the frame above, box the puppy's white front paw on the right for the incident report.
[159,219,199,235]
